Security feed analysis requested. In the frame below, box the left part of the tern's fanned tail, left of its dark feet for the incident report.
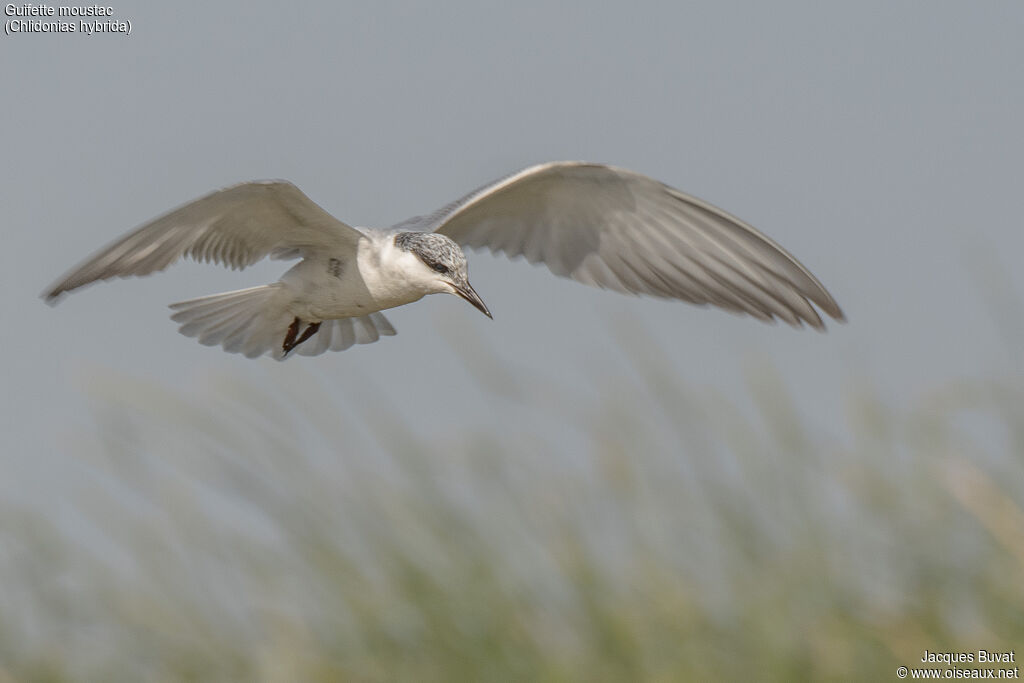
[164,283,294,358]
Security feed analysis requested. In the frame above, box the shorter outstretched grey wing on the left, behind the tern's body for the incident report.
[43,180,361,303]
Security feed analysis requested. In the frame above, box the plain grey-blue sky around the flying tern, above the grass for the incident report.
[0,2,1024,495]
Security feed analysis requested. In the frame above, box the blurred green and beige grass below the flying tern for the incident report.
[0,327,1024,682]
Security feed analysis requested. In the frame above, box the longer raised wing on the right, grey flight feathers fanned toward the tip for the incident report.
[398,162,845,329]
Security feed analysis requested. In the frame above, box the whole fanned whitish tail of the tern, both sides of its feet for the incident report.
[171,283,394,360]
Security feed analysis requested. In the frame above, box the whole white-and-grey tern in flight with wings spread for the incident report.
[43,162,845,359]
